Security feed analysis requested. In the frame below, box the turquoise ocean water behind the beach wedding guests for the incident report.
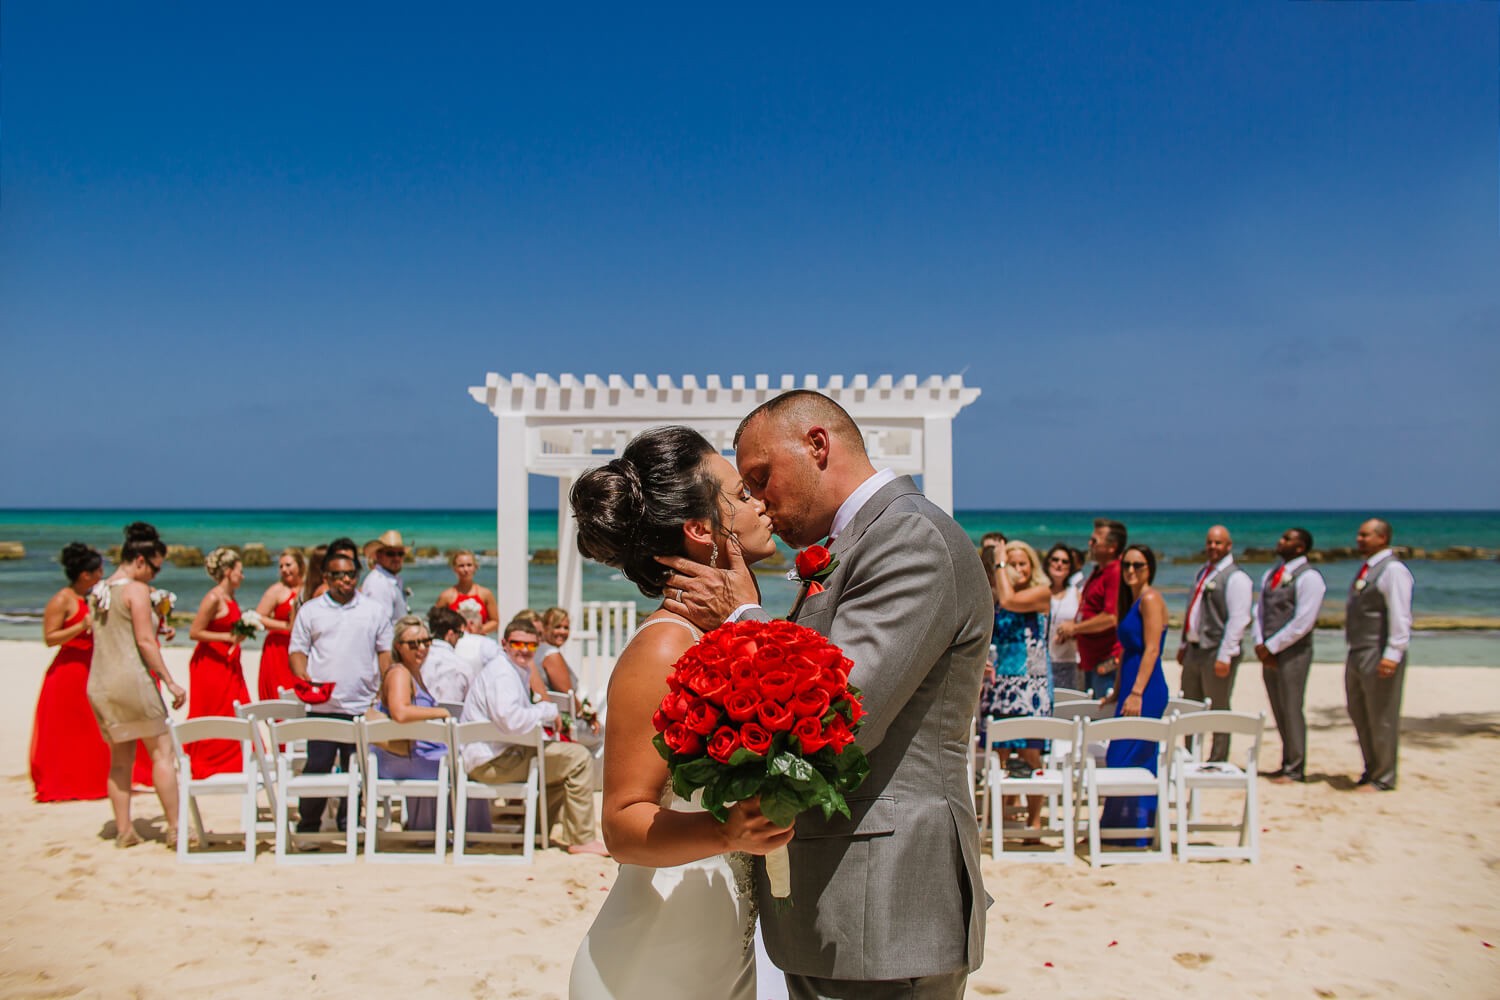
[0,510,1500,666]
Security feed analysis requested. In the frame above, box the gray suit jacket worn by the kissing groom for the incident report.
[744,477,995,981]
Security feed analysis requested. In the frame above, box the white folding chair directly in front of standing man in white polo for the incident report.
[270,715,363,864]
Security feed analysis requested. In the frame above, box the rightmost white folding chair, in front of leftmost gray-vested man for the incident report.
[1172,712,1266,864]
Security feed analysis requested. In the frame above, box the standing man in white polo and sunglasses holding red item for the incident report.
[290,552,392,834]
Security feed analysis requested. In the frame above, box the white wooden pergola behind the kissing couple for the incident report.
[470,372,980,622]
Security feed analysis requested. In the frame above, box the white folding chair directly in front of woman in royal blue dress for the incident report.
[1080,717,1172,868]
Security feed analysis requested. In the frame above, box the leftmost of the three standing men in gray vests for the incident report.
[1178,525,1254,760]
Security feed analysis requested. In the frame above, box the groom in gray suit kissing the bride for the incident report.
[663,390,993,1000]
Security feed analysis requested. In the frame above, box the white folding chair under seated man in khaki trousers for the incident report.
[449,720,548,865]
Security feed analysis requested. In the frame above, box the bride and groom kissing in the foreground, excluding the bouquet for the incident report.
[569,390,993,1000]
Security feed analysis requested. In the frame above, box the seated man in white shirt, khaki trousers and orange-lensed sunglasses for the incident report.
[462,619,609,856]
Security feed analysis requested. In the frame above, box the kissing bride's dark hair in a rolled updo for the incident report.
[569,426,720,597]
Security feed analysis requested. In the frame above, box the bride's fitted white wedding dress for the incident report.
[569,618,756,1000]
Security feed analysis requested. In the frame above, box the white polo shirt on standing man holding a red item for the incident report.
[288,591,392,715]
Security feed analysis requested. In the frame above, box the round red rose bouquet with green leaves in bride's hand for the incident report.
[651,621,870,898]
